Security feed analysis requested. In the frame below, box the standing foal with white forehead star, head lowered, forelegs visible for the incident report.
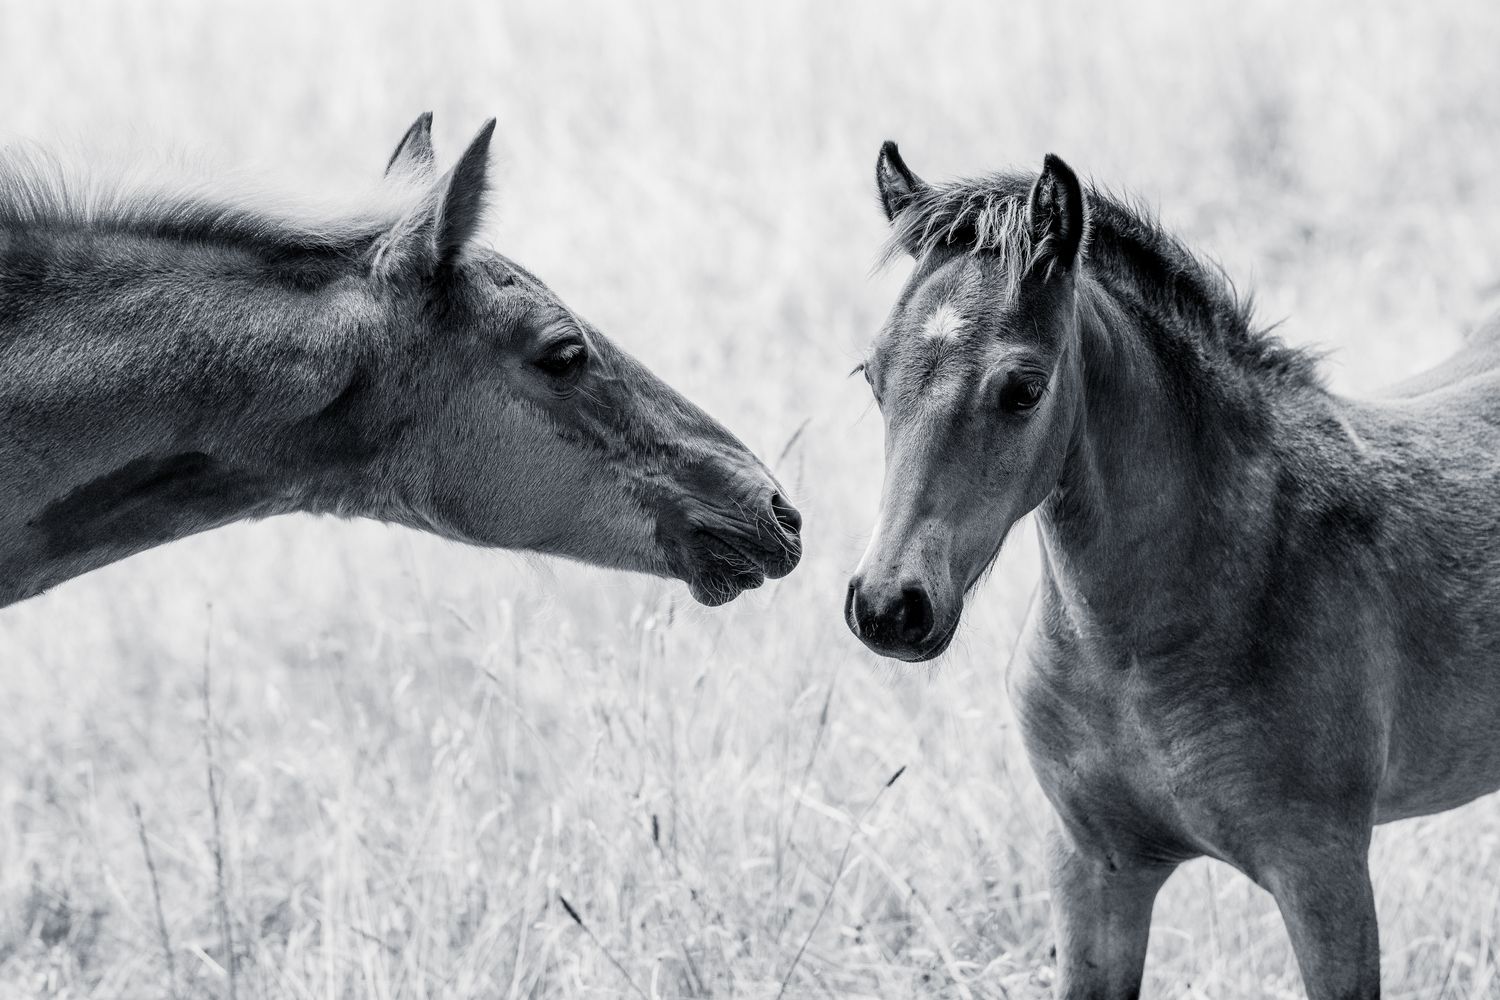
[846,144,1500,1000]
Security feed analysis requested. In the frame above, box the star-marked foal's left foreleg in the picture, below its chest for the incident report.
[1049,831,1175,1000]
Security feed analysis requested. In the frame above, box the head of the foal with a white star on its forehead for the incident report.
[845,142,1085,660]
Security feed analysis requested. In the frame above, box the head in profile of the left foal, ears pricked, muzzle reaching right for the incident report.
[371,115,801,604]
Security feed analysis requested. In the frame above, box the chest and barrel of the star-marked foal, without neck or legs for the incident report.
[1011,352,1500,827]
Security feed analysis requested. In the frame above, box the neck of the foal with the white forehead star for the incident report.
[1038,280,1275,654]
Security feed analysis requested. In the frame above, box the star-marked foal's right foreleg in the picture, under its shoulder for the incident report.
[1262,844,1380,1000]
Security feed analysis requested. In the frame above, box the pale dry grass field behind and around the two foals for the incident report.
[0,0,1500,1000]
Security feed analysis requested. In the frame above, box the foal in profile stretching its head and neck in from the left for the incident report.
[0,114,801,606]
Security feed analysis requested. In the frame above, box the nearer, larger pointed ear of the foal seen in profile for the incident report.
[372,118,495,284]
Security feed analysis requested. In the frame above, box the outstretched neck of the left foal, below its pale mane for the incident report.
[0,226,402,604]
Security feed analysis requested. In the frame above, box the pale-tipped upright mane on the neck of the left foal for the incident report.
[0,144,428,258]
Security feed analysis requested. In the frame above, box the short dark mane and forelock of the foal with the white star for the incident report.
[881,172,1320,385]
